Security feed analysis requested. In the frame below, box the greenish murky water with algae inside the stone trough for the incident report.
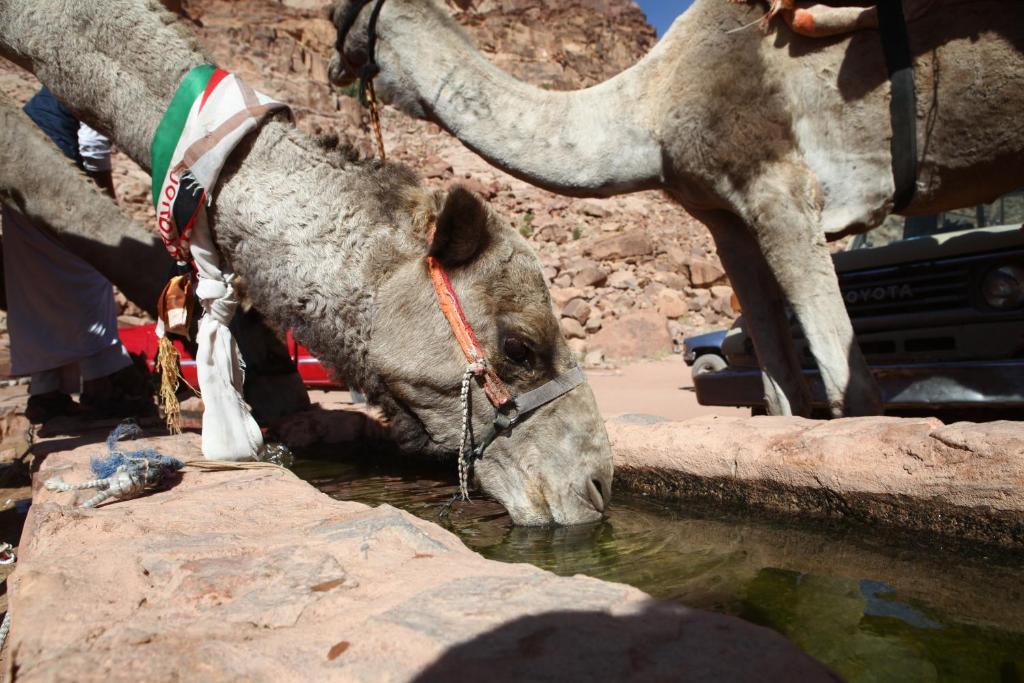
[295,460,1024,683]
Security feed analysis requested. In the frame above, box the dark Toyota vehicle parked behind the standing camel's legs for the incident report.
[693,190,1024,419]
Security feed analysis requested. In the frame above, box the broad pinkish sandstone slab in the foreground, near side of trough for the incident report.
[8,434,836,681]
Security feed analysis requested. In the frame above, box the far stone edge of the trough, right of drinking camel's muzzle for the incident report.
[607,416,1024,551]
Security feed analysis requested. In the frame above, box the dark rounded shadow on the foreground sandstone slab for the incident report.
[415,603,840,683]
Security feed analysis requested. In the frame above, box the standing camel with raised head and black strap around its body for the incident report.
[330,0,1024,415]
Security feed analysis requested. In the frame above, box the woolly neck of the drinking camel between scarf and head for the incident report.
[213,121,413,397]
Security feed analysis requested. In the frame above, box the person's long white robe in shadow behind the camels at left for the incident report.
[2,207,131,394]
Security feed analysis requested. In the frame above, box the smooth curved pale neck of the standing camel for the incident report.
[364,2,662,196]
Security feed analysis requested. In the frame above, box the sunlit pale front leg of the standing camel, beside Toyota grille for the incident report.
[748,171,882,417]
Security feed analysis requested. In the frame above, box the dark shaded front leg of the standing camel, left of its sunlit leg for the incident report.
[693,211,811,416]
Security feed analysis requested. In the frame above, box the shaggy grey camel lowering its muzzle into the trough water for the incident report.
[0,0,612,524]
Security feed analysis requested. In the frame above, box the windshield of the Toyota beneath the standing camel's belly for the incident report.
[850,189,1024,249]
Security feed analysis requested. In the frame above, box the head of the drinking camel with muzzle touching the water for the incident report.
[362,187,612,525]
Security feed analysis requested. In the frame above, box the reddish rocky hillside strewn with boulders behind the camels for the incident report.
[0,0,735,366]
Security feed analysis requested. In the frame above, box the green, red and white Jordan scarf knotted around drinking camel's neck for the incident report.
[151,65,288,460]
